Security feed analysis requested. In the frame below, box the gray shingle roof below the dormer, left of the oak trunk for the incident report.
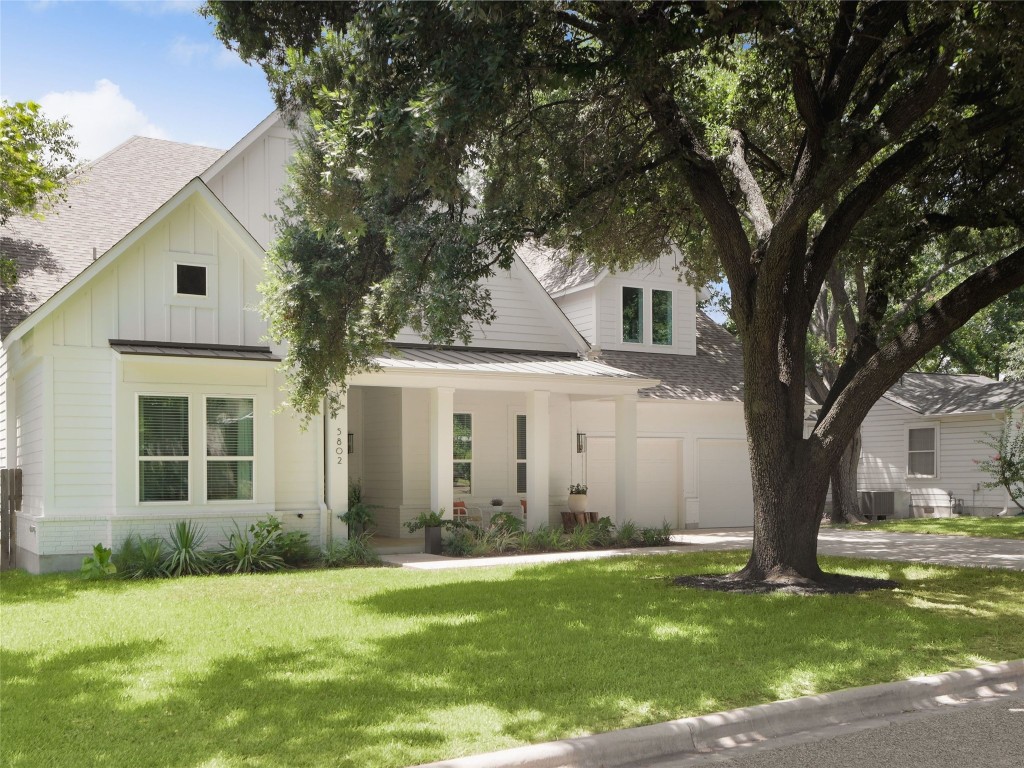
[601,311,743,401]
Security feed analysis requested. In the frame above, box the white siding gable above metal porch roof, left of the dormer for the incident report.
[395,258,580,352]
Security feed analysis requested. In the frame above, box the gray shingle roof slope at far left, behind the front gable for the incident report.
[0,136,223,338]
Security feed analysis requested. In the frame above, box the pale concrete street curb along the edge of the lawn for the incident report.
[419,659,1024,768]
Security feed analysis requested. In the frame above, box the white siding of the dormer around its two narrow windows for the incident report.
[596,254,697,354]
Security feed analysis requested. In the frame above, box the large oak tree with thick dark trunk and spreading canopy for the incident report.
[205,2,1024,581]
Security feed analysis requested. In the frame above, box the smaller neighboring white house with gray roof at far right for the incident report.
[858,373,1024,517]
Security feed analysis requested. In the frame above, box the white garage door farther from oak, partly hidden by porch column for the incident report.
[587,437,681,527]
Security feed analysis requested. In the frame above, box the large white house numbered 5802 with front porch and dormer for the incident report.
[0,115,753,571]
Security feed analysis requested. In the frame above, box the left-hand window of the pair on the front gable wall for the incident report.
[138,394,188,502]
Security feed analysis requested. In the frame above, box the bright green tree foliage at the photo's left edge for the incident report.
[0,101,78,286]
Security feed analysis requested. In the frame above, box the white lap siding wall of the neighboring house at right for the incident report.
[857,398,1007,511]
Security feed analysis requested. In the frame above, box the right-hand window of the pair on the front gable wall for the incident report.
[206,397,255,502]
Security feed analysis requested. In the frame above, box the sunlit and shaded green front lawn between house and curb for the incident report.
[0,553,1024,768]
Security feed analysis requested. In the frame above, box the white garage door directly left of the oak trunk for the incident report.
[697,439,754,528]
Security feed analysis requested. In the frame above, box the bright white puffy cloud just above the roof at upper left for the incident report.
[39,79,168,160]
